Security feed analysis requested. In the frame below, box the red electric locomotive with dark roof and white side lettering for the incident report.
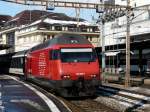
[10,34,100,97]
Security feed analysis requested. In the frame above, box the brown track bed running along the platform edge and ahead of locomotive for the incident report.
[19,77,116,112]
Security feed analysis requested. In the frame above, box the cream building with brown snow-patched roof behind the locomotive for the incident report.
[0,10,100,54]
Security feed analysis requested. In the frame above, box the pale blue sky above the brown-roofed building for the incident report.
[0,0,99,22]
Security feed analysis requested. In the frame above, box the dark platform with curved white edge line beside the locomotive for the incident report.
[0,75,70,112]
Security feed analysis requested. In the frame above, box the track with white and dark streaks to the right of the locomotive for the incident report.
[97,86,150,111]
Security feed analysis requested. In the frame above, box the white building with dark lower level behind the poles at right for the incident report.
[104,0,150,74]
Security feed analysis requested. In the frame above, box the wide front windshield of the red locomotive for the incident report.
[60,48,96,62]
